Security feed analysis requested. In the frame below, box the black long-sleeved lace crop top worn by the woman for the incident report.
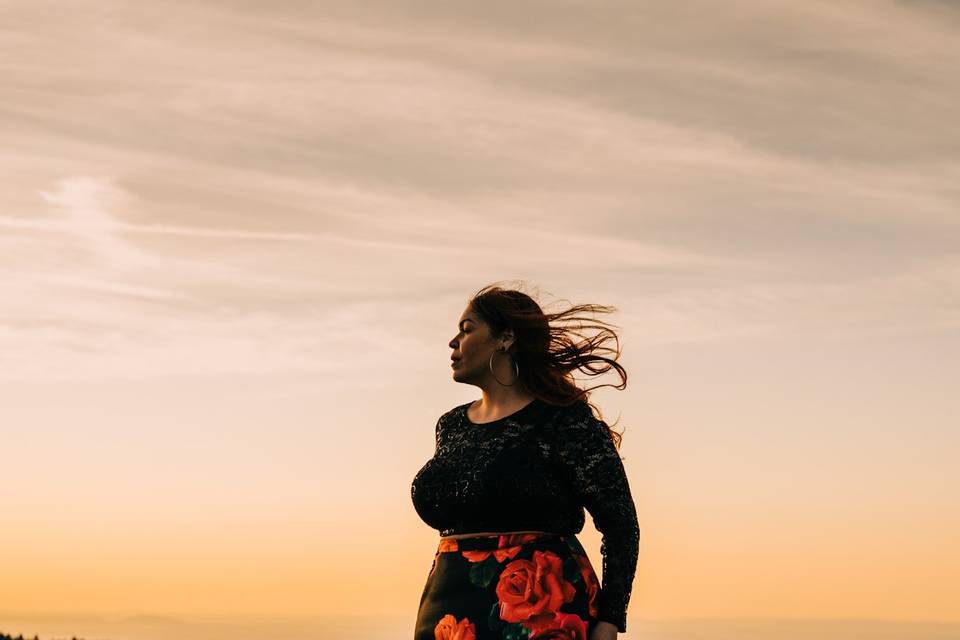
[411,399,640,633]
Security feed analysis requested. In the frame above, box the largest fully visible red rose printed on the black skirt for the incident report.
[496,551,577,622]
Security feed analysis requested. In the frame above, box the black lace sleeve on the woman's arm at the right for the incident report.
[558,401,640,633]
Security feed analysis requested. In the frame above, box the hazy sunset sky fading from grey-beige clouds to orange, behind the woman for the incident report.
[0,0,960,630]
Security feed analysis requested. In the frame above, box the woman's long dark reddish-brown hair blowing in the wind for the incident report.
[468,285,627,449]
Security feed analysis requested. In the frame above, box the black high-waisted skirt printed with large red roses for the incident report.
[414,533,600,640]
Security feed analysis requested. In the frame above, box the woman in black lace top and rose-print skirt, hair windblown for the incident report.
[411,286,640,640]
